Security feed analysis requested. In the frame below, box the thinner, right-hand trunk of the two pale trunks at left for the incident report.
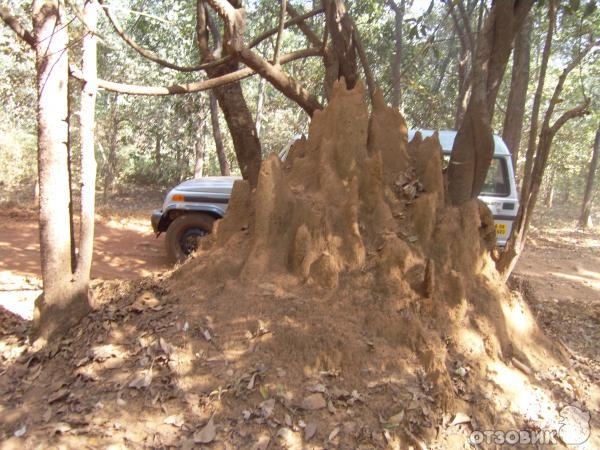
[75,0,98,291]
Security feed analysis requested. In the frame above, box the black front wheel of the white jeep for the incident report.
[165,213,215,263]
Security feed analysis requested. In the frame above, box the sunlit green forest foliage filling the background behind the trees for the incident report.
[0,0,600,220]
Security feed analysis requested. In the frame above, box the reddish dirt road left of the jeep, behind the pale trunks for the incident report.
[0,208,168,318]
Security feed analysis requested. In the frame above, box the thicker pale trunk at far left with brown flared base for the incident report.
[32,0,90,340]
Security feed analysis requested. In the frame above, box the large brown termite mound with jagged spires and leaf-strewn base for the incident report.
[0,84,596,449]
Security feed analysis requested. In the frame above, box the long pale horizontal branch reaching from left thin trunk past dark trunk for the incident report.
[69,48,322,96]
